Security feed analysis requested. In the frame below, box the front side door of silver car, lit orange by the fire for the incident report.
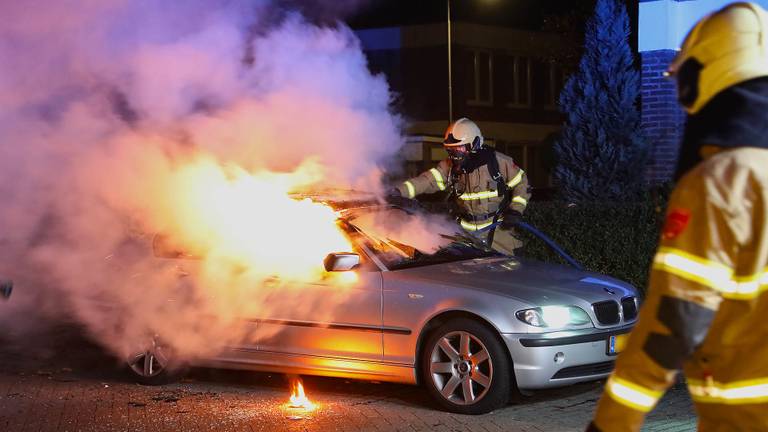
[257,263,383,361]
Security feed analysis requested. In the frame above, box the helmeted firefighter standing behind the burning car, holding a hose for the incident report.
[397,118,531,255]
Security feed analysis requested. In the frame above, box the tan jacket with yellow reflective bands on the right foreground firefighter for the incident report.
[594,147,768,431]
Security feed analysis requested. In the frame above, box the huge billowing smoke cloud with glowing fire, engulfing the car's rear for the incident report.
[0,0,424,362]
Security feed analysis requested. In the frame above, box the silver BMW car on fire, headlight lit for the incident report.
[128,206,639,414]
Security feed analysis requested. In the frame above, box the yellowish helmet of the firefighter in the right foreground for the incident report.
[666,2,768,114]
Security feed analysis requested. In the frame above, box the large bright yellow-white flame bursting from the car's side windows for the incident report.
[167,158,352,280]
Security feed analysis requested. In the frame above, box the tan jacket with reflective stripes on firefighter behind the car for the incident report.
[398,152,531,232]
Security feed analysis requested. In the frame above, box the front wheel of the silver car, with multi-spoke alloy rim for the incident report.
[421,318,511,414]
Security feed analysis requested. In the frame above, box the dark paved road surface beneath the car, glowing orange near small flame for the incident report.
[0,326,696,432]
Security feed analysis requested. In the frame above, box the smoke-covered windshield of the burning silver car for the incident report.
[345,208,498,270]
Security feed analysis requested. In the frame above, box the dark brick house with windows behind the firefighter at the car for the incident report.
[356,22,569,188]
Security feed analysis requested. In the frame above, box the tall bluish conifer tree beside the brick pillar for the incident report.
[554,0,647,203]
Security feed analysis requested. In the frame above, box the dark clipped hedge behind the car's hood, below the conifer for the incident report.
[520,197,665,293]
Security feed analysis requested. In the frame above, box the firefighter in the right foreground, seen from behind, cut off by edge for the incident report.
[588,3,768,431]
